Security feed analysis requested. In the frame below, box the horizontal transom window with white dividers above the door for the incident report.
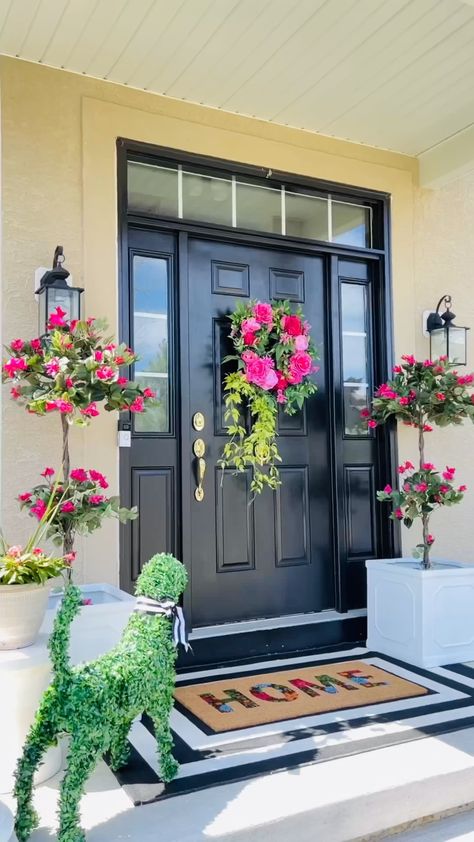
[127,161,373,248]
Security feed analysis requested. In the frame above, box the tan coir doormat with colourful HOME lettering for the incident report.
[175,661,428,734]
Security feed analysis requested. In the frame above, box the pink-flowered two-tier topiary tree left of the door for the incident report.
[2,307,155,554]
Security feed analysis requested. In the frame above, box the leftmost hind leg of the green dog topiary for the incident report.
[13,715,56,842]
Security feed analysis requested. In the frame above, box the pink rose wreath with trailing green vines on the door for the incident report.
[219,301,318,493]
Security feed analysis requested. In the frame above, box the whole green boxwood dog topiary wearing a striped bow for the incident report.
[14,553,187,842]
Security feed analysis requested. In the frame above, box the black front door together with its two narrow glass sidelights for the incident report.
[120,226,390,626]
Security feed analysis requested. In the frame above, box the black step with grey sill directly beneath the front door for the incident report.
[178,609,367,671]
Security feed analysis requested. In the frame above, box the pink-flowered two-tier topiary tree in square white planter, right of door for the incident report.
[361,355,474,568]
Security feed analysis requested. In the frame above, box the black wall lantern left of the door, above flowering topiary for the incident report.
[36,246,84,336]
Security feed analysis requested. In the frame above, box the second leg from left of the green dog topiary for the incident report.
[58,733,102,842]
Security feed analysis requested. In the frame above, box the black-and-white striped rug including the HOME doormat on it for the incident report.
[107,647,474,805]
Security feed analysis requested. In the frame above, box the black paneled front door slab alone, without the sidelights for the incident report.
[182,239,334,625]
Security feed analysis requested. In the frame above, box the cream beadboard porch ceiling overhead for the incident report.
[0,0,474,185]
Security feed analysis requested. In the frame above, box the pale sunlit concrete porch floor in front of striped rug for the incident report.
[3,728,474,842]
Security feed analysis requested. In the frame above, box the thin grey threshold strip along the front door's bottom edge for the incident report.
[189,608,367,641]
